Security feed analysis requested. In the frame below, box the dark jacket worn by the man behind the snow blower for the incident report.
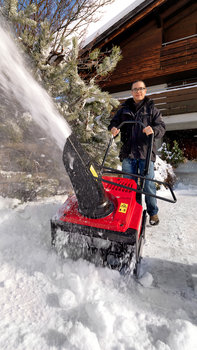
[108,97,165,162]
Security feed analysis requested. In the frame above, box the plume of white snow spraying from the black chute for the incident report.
[0,18,71,149]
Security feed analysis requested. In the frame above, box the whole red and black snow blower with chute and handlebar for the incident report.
[51,121,176,277]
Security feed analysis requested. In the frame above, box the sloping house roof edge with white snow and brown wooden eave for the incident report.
[82,0,167,48]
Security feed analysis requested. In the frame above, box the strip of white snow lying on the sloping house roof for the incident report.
[83,0,145,46]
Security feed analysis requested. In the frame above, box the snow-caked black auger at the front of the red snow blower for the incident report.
[52,224,136,273]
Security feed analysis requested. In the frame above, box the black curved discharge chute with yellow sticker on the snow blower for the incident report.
[63,134,113,219]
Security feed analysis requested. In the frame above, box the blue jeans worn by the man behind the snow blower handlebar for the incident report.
[122,158,159,216]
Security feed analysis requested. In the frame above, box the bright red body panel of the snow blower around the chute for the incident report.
[56,176,143,232]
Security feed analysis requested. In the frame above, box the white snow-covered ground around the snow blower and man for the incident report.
[0,185,197,350]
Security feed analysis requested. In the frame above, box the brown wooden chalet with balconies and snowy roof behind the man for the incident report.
[83,0,197,159]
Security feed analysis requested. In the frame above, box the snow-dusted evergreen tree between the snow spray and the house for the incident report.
[3,0,121,162]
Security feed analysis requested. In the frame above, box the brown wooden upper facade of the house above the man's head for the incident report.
[101,2,197,92]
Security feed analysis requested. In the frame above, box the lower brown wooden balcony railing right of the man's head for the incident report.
[148,85,197,116]
